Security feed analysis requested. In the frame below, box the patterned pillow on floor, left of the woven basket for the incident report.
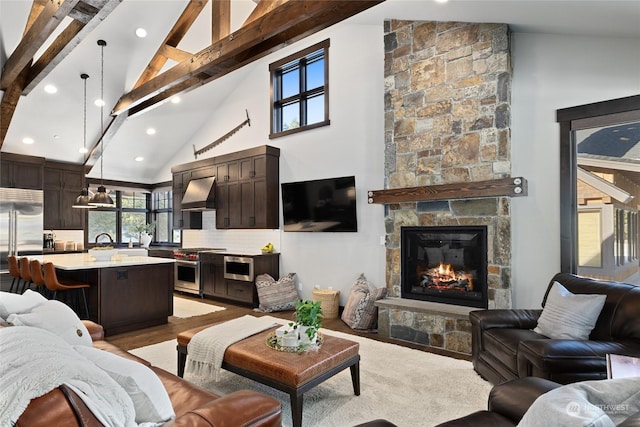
[256,273,300,313]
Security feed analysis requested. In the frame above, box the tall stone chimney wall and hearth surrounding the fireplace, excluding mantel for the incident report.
[379,20,511,353]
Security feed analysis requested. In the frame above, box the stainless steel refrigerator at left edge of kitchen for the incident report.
[0,187,44,273]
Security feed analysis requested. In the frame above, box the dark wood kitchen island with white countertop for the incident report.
[41,253,174,336]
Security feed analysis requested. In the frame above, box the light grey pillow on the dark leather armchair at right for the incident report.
[533,282,607,340]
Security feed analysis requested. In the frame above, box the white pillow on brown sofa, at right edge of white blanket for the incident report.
[74,346,175,423]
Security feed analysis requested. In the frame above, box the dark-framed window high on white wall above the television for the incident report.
[269,39,330,138]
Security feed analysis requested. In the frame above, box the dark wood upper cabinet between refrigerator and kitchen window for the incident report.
[44,161,85,230]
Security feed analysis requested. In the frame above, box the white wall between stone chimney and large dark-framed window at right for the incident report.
[511,33,640,308]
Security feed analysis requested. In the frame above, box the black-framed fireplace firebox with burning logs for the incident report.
[401,225,487,308]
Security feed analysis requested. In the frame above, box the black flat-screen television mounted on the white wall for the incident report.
[281,176,358,232]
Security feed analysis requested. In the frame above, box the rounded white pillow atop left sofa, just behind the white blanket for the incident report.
[7,300,93,347]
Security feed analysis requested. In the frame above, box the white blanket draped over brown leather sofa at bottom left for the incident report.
[0,326,136,427]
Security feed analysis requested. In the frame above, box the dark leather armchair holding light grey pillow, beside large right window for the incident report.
[469,273,640,384]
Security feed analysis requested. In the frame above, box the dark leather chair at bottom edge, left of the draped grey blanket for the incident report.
[437,377,640,427]
